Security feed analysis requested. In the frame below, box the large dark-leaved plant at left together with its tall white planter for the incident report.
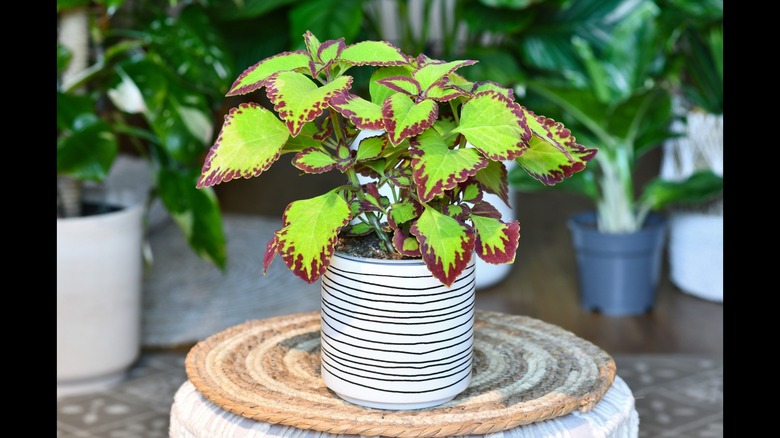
[57,1,230,395]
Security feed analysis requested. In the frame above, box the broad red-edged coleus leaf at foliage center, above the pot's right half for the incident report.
[409,129,488,203]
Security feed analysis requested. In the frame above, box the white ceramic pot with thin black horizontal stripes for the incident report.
[320,253,476,410]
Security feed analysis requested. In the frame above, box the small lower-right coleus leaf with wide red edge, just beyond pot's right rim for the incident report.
[471,213,520,265]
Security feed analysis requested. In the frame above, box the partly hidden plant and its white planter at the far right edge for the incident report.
[660,0,723,302]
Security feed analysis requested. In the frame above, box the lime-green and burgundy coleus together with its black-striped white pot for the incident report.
[197,32,596,409]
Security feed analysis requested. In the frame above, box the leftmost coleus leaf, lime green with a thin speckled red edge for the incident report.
[196,103,290,188]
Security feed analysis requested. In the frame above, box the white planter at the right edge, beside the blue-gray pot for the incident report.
[669,212,723,302]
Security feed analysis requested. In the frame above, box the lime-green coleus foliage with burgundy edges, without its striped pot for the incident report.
[197,31,596,286]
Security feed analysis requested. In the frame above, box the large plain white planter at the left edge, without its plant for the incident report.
[57,204,144,397]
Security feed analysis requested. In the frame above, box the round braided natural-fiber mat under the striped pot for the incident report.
[185,310,615,437]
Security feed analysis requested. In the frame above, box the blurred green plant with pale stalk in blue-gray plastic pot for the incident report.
[509,2,722,316]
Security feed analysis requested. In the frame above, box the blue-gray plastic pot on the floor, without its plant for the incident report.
[567,212,667,316]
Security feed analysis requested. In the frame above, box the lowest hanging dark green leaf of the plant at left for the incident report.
[157,168,227,270]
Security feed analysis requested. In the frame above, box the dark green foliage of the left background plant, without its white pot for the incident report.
[57,0,235,267]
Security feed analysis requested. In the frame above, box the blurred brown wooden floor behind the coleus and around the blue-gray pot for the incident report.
[218,154,723,358]
